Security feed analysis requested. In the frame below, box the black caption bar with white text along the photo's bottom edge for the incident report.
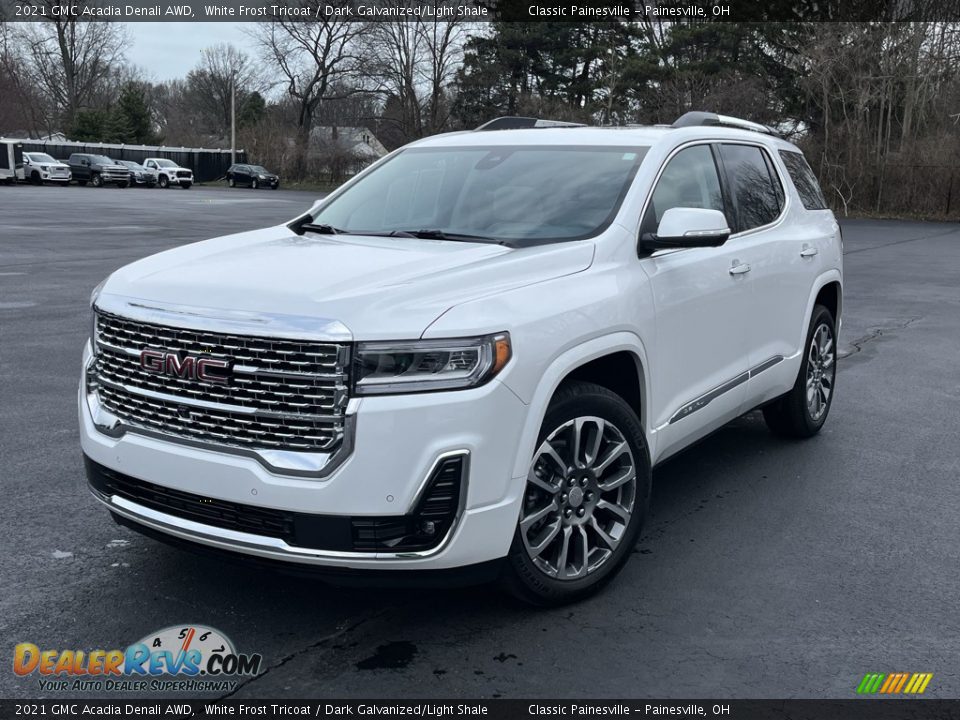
[0,698,960,720]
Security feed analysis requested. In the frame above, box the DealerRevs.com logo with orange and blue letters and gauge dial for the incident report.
[13,625,263,692]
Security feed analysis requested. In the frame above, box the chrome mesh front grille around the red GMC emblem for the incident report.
[92,312,349,452]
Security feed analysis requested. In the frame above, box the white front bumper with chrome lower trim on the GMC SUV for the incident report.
[79,348,526,570]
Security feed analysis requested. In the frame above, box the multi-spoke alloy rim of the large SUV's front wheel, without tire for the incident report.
[520,416,637,580]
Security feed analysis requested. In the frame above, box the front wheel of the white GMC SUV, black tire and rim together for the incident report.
[503,382,650,605]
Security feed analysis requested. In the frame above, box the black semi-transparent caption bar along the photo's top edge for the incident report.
[0,0,960,23]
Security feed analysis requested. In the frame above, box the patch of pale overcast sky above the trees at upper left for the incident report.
[127,22,254,81]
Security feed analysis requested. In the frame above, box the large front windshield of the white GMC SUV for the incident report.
[313,145,647,246]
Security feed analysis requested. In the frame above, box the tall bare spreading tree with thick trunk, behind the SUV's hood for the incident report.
[253,10,369,178]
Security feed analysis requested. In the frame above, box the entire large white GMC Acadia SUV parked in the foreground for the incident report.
[86,113,842,603]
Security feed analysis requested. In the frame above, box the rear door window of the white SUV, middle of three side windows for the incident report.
[720,145,784,232]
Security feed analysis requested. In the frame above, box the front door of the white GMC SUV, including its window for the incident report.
[640,142,751,457]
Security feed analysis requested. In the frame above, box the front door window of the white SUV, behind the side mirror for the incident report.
[643,145,725,232]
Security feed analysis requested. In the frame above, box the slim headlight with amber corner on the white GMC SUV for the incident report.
[354,333,511,395]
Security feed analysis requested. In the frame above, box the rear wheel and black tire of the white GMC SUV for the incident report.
[763,305,837,438]
